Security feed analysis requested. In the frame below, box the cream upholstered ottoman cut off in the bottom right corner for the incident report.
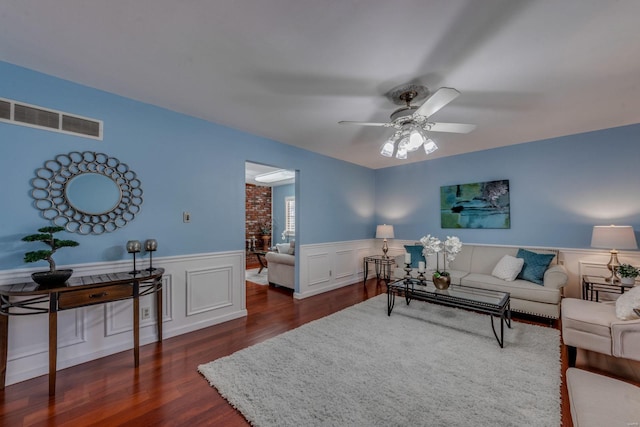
[566,368,640,427]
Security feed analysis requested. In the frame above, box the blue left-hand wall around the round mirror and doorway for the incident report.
[0,62,375,270]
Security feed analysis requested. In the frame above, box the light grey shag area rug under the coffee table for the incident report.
[198,295,561,427]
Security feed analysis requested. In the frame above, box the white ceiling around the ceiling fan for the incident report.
[0,0,640,168]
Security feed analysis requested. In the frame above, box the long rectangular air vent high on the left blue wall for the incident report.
[0,98,103,140]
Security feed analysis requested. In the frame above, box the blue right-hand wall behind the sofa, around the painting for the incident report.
[376,125,640,248]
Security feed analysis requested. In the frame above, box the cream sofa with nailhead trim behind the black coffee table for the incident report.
[394,244,568,319]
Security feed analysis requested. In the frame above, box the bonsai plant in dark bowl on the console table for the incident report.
[22,226,78,286]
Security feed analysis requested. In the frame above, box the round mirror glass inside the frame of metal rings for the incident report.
[65,173,121,215]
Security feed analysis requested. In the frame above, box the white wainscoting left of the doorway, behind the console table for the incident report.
[0,251,247,392]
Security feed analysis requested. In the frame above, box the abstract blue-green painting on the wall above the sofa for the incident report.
[440,179,511,228]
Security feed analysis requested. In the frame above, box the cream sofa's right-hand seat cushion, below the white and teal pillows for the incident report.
[460,273,561,304]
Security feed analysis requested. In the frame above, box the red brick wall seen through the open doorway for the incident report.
[245,184,271,268]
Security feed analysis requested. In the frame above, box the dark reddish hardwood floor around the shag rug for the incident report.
[0,279,572,426]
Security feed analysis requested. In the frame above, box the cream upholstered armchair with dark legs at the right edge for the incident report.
[562,298,640,366]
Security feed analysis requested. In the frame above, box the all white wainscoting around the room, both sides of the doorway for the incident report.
[0,239,640,385]
